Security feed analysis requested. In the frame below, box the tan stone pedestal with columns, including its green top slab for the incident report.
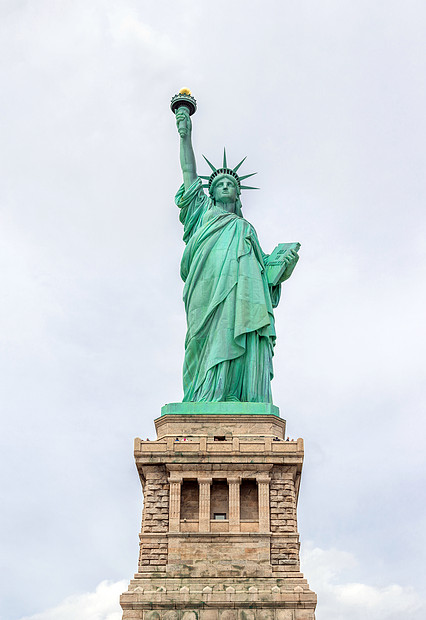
[121,403,316,620]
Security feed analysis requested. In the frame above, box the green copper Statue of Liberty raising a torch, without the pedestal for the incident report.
[172,91,300,403]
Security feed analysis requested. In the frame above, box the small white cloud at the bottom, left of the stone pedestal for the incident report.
[21,581,127,620]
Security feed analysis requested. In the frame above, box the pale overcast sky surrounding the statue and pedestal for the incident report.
[0,0,426,620]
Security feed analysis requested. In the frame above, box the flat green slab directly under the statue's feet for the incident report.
[161,402,280,417]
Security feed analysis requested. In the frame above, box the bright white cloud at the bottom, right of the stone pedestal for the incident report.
[302,544,426,620]
